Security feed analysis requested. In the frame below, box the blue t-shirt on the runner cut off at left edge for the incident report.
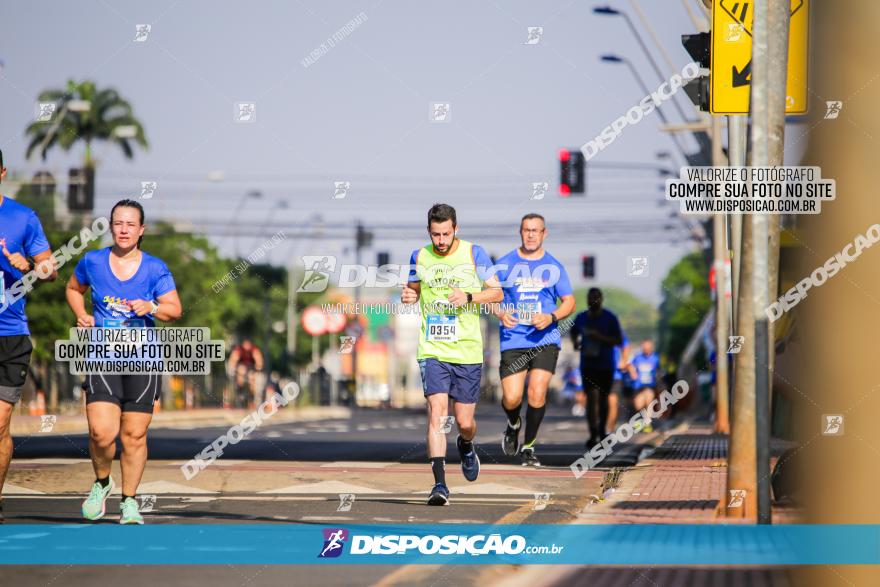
[0,197,49,336]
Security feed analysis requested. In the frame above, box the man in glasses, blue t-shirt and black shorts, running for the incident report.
[495,214,575,467]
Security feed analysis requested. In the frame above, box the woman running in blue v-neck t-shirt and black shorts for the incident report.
[67,200,183,524]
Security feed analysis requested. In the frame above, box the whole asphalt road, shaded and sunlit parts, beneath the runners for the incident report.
[0,405,785,587]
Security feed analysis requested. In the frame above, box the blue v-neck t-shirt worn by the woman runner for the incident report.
[73,247,177,328]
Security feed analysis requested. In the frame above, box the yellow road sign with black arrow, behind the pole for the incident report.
[709,0,810,114]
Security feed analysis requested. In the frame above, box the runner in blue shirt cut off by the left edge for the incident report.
[0,151,58,524]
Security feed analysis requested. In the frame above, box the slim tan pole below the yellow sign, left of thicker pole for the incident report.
[712,116,730,434]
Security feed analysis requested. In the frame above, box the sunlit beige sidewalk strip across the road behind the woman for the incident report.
[11,406,351,436]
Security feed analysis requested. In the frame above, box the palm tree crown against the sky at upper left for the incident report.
[25,80,147,167]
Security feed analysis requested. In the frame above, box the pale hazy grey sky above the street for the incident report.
[0,0,808,300]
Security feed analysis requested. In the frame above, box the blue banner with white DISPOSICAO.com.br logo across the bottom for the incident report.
[0,524,880,566]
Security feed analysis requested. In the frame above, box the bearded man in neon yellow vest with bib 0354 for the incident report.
[401,204,504,505]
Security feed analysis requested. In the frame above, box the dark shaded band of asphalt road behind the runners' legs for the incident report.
[14,405,638,467]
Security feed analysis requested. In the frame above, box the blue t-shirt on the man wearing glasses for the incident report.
[495,249,572,351]
